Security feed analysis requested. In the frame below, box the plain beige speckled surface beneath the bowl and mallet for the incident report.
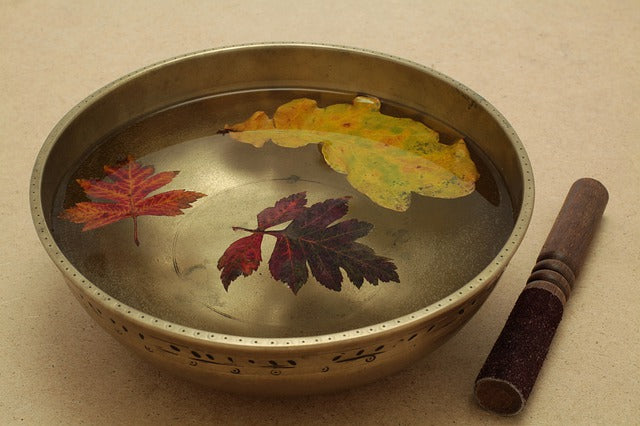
[0,0,640,425]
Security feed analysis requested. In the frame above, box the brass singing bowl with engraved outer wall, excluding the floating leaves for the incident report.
[31,43,534,394]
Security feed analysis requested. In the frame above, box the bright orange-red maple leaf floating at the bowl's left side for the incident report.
[60,156,206,246]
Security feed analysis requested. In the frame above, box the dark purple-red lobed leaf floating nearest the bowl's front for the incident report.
[218,192,399,294]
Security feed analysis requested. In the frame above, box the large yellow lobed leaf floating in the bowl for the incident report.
[225,96,479,211]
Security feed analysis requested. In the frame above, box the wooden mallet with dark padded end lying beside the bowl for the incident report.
[475,178,609,415]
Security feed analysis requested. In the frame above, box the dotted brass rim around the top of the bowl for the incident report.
[29,42,535,349]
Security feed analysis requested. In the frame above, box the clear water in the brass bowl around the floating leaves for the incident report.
[54,89,514,337]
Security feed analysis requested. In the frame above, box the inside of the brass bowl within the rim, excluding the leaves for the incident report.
[33,45,531,338]
